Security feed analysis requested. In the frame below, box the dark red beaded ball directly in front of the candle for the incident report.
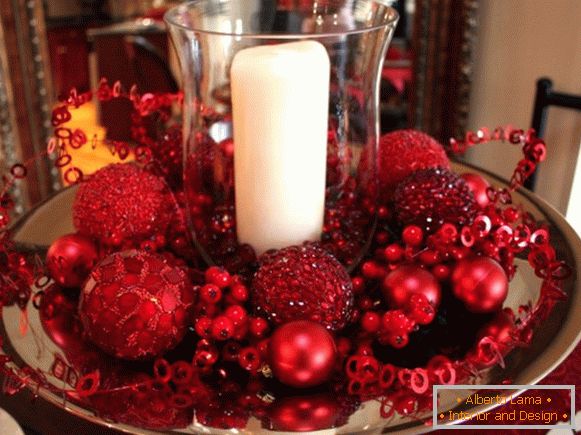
[252,245,353,331]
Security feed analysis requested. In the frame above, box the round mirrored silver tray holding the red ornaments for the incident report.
[0,163,581,434]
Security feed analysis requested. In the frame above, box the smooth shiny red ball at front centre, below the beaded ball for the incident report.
[269,320,337,388]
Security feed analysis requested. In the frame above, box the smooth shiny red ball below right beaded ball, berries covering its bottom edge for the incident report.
[382,264,441,309]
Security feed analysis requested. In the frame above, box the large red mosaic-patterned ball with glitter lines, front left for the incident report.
[79,250,195,360]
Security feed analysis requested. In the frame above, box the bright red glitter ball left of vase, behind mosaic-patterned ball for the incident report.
[73,163,174,245]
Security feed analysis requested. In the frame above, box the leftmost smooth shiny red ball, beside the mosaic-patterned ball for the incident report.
[46,234,99,288]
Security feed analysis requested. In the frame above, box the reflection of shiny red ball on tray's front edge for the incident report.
[268,394,341,432]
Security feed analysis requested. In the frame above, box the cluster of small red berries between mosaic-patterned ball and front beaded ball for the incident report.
[194,266,269,373]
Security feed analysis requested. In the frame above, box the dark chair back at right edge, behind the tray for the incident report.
[525,77,581,190]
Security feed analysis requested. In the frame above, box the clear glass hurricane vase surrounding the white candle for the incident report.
[166,0,398,271]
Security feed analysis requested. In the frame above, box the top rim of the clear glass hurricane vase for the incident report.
[163,0,399,40]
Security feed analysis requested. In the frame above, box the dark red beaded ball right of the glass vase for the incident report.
[394,168,478,233]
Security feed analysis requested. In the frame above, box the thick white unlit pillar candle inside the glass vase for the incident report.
[230,41,330,254]
